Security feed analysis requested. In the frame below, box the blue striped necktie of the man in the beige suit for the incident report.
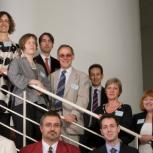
[55,70,66,110]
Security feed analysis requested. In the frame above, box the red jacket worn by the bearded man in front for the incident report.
[20,141,80,153]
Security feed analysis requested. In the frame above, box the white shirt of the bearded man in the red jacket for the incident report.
[42,139,58,153]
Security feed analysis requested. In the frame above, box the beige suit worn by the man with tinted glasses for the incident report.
[51,68,89,135]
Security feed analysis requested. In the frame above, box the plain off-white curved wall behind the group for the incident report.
[1,0,142,112]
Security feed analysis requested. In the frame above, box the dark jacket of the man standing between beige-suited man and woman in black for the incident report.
[84,87,107,127]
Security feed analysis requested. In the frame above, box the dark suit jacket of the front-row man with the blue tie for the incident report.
[90,143,139,153]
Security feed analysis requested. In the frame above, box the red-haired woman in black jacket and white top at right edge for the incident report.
[132,90,153,153]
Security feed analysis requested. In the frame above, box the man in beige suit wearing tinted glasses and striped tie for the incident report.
[51,44,89,146]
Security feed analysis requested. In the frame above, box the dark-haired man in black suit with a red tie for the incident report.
[34,32,60,76]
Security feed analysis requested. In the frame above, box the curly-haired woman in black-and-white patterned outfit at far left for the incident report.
[0,11,19,137]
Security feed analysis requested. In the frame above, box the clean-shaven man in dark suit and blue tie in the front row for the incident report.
[90,114,138,153]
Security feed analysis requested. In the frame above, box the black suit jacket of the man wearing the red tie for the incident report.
[34,55,60,76]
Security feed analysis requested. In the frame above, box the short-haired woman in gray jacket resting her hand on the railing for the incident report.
[8,33,50,148]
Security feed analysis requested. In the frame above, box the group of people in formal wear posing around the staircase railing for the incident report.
[0,11,153,153]
